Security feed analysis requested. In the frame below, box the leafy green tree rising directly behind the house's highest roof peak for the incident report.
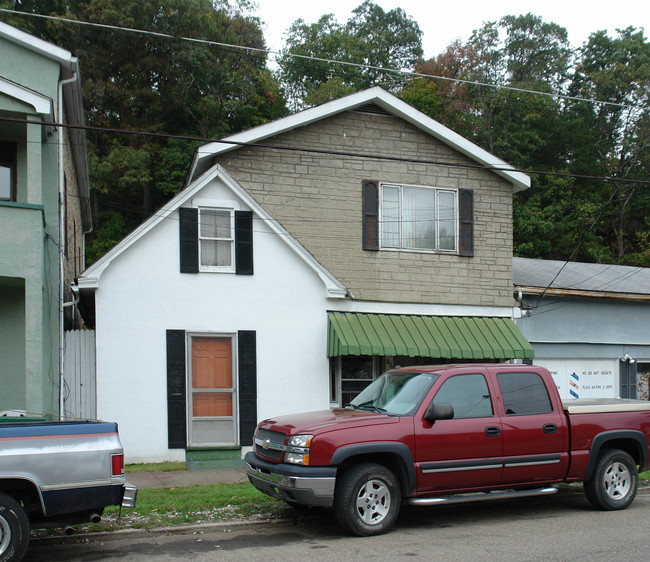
[278,0,422,108]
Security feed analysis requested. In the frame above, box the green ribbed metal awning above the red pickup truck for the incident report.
[327,312,534,359]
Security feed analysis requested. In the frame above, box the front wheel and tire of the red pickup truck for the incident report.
[334,463,402,537]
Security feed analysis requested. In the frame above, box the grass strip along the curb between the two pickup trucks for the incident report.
[84,482,293,532]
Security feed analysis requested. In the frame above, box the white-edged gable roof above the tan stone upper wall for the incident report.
[187,86,530,192]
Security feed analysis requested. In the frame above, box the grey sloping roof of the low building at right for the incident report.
[512,258,650,300]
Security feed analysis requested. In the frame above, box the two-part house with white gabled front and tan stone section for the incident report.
[78,88,533,462]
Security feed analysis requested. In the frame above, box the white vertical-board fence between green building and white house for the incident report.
[61,330,97,420]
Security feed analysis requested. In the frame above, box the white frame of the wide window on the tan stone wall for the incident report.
[379,182,459,255]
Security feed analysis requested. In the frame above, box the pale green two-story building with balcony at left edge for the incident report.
[0,23,91,416]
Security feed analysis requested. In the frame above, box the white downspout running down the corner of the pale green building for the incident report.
[57,71,78,419]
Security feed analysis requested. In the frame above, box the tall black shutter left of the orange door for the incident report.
[167,330,187,449]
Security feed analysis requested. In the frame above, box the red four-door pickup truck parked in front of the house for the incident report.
[246,363,650,536]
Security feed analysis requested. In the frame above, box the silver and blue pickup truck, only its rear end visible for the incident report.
[0,418,137,562]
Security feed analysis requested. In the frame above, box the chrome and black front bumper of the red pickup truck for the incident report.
[245,452,336,507]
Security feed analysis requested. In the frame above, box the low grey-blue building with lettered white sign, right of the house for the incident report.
[513,258,650,400]
